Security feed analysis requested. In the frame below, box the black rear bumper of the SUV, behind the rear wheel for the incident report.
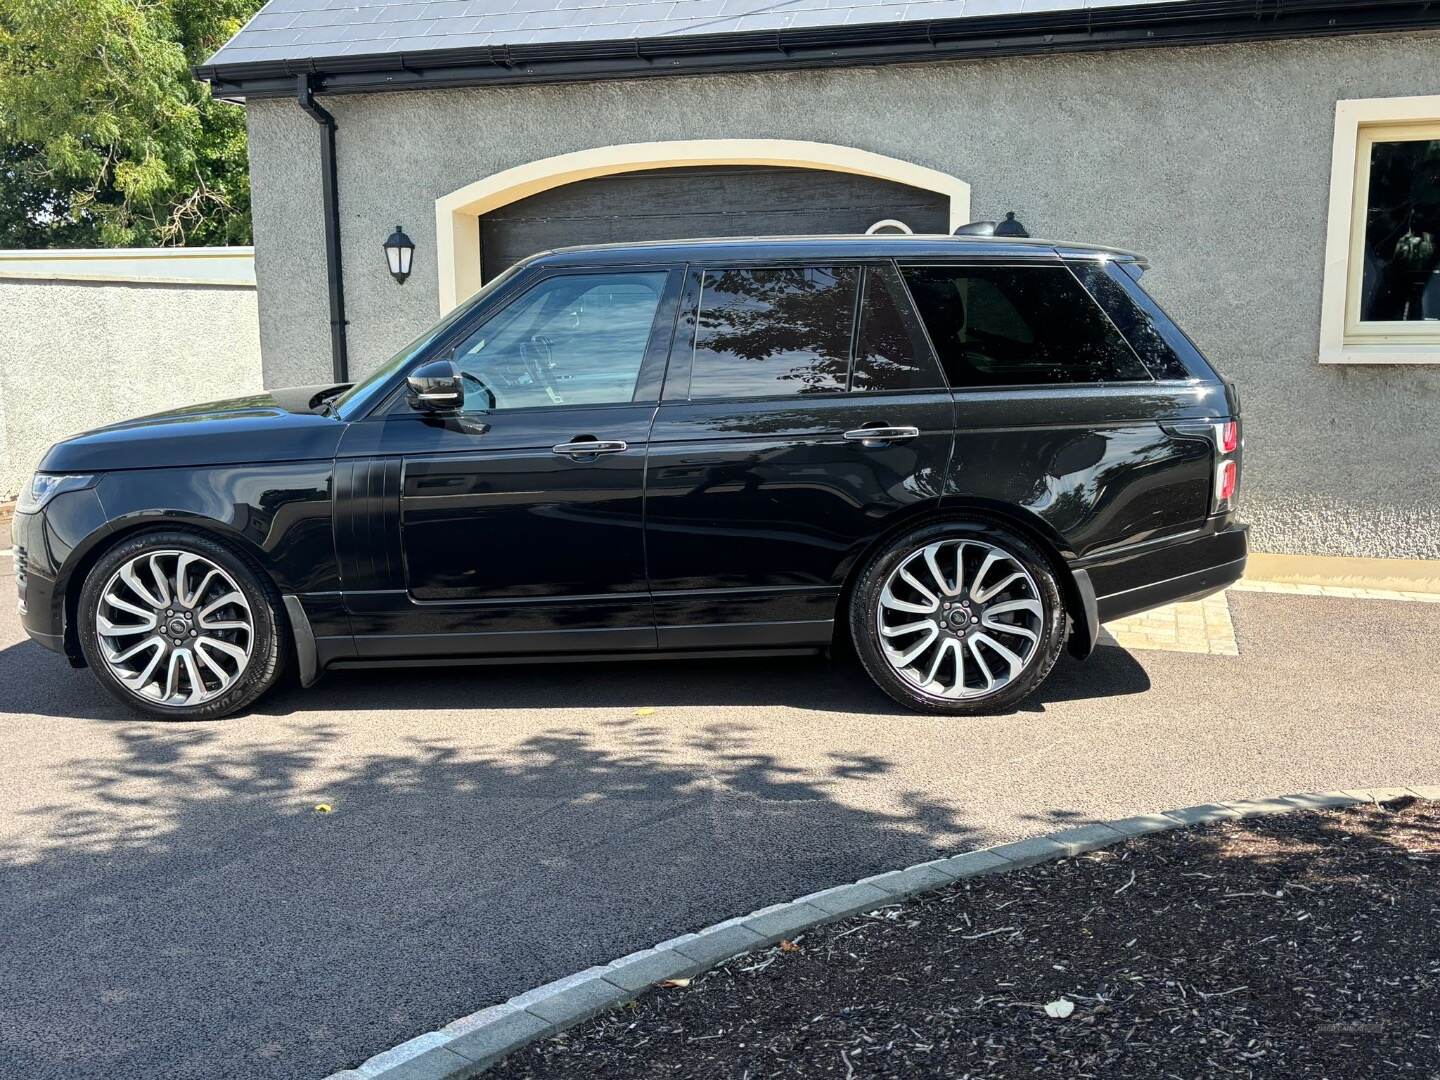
[1077,521,1250,622]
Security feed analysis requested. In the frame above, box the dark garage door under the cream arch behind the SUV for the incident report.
[480,166,949,281]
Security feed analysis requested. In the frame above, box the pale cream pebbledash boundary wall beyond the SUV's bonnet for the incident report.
[0,248,261,503]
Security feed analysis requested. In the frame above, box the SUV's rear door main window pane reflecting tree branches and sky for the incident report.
[690,266,860,397]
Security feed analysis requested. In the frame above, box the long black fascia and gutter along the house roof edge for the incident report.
[194,0,1440,99]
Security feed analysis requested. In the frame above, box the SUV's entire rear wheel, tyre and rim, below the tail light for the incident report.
[850,521,1066,714]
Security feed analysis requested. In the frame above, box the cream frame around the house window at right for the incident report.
[1319,95,1440,364]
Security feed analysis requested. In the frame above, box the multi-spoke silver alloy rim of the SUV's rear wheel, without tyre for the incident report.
[876,540,1044,698]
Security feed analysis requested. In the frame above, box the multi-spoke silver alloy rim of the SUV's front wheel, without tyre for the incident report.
[95,550,255,708]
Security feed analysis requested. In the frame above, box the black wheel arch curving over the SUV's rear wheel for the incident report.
[834,498,1100,658]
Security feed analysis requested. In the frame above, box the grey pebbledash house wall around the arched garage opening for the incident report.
[248,33,1440,559]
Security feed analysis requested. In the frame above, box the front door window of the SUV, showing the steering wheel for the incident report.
[455,272,667,410]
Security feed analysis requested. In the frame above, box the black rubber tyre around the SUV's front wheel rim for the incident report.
[76,530,288,720]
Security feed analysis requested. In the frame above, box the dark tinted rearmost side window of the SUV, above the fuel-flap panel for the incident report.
[904,266,1149,387]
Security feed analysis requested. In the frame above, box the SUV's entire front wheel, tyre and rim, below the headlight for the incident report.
[78,531,284,720]
